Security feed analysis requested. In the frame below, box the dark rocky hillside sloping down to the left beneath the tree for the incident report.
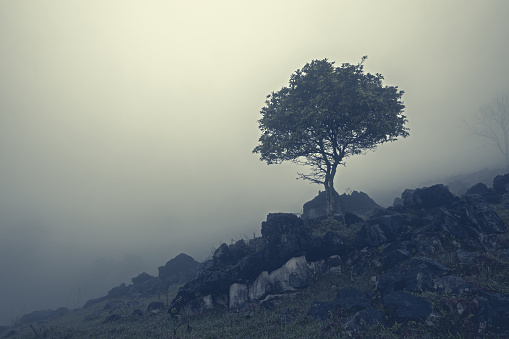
[0,174,509,338]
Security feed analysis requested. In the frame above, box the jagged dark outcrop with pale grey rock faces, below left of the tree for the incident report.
[169,213,345,314]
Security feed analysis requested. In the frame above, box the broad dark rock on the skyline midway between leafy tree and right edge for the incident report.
[401,184,458,209]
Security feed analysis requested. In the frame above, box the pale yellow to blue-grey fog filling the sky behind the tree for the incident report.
[0,0,509,324]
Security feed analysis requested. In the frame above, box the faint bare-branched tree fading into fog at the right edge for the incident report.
[465,94,509,168]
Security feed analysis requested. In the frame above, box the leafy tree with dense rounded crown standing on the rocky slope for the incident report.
[253,56,408,217]
